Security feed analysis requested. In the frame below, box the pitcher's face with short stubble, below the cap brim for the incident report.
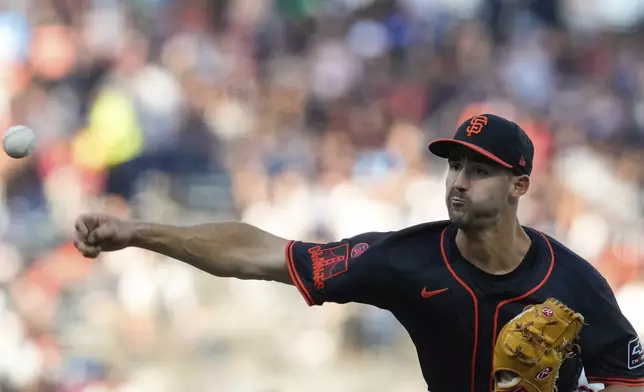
[445,151,515,229]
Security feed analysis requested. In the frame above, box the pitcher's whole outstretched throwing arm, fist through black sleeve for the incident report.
[74,214,397,308]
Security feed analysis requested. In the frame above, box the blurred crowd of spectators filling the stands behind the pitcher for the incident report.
[0,0,644,392]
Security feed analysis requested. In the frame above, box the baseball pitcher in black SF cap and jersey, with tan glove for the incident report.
[76,114,644,392]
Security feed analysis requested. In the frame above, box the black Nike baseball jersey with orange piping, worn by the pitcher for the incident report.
[286,221,644,392]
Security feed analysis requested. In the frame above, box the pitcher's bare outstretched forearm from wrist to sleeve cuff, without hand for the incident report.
[131,222,291,284]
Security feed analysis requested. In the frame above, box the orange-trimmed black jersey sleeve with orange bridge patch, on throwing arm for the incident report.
[286,233,394,309]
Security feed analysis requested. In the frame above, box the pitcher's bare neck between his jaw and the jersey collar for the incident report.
[456,217,532,275]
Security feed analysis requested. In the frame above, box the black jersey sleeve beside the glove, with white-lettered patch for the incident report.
[580,281,644,386]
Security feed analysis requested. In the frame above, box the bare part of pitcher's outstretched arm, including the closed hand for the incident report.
[75,214,292,284]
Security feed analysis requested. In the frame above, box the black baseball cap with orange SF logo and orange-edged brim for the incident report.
[429,113,534,175]
